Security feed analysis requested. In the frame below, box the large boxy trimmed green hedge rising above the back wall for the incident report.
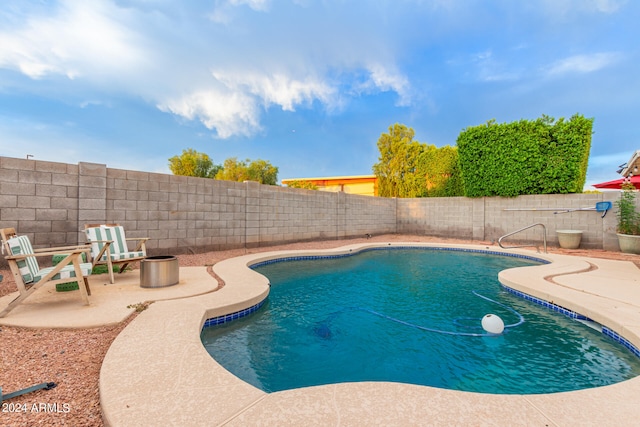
[457,114,593,197]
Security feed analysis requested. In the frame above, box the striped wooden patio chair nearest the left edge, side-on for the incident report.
[0,228,92,317]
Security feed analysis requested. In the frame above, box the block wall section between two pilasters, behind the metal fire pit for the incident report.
[107,169,246,253]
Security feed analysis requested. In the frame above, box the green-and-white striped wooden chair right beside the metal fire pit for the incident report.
[84,224,149,283]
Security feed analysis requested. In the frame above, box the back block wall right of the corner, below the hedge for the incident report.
[398,192,624,251]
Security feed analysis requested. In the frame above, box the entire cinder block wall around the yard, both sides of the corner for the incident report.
[0,157,640,262]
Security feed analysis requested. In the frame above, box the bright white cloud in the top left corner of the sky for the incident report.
[0,0,145,79]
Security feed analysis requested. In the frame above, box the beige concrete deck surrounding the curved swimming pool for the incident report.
[0,243,640,427]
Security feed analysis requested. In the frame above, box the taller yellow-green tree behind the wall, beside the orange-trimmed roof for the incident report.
[373,123,425,197]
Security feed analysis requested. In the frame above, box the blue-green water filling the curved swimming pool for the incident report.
[201,249,640,394]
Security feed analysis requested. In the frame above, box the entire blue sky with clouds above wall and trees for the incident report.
[0,0,640,184]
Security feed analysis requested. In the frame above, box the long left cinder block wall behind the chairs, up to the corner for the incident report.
[0,157,396,262]
